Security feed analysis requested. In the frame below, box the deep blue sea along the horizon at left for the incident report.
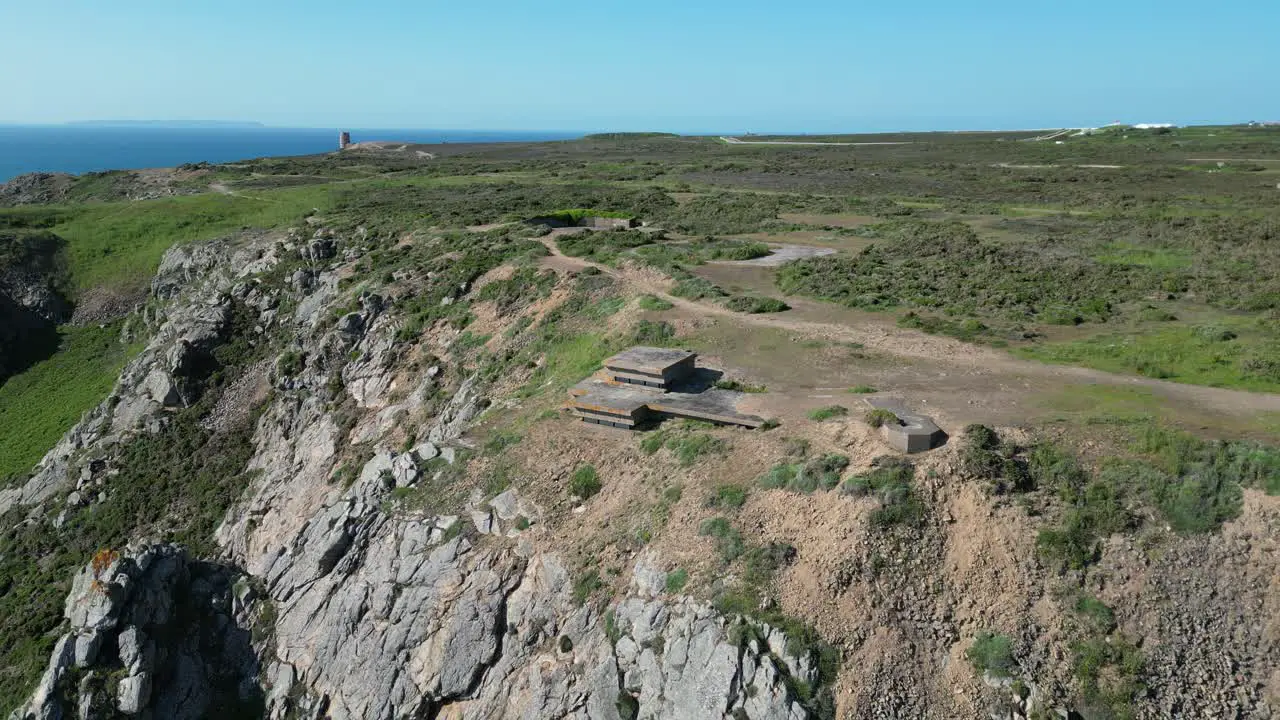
[0,126,582,182]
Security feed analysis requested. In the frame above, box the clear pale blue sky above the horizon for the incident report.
[0,0,1280,132]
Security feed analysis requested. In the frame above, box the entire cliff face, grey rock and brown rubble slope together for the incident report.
[0,224,1280,720]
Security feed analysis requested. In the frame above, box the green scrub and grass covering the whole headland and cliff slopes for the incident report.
[0,128,1280,717]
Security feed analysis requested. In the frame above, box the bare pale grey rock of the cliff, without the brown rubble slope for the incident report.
[0,228,817,720]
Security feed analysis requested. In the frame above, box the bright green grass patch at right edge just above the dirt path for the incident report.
[1015,325,1280,392]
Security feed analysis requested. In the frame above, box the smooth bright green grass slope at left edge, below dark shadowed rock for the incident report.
[0,324,141,482]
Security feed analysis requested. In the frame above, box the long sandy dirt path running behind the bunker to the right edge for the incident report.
[543,236,1280,419]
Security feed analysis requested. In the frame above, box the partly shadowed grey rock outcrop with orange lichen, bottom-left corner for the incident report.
[14,546,261,720]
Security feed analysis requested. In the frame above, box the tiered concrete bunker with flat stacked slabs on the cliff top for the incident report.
[570,347,764,429]
